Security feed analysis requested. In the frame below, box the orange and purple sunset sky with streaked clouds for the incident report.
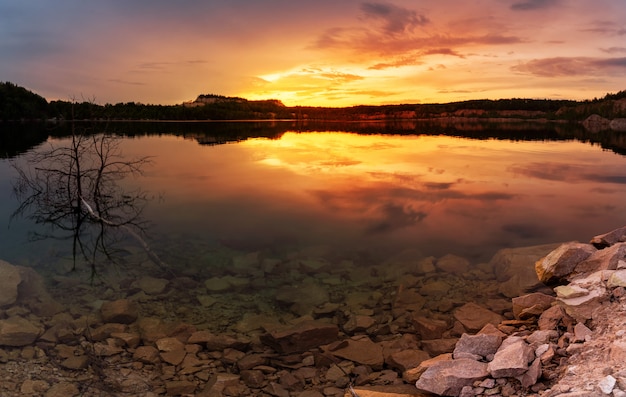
[0,0,626,106]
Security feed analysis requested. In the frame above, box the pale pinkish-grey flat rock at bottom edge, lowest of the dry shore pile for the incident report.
[415,359,489,396]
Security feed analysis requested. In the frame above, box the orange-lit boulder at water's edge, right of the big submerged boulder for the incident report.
[535,241,597,284]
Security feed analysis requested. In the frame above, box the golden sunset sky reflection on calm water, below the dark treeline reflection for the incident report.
[0,124,626,278]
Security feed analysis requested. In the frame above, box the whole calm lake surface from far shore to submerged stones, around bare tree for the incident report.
[0,122,626,326]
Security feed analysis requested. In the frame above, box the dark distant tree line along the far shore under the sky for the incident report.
[0,82,626,121]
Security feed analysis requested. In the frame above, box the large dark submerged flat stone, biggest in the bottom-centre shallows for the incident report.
[260,321,336,352]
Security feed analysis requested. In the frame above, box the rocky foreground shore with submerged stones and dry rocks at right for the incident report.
[0,227,626,397]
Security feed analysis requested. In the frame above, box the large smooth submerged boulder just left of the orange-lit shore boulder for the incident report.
[489,244,558,298]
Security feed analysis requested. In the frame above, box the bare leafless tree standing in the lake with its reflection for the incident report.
[13,130,161,275]
